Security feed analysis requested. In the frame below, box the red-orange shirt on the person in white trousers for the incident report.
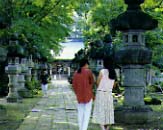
[72,67,94,103]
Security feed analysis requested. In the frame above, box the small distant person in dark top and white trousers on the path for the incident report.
[40,70,49,97]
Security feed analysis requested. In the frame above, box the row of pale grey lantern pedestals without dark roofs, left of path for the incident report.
[5,57,50,102]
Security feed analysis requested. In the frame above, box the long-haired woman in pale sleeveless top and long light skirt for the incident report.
[92,58,116,130]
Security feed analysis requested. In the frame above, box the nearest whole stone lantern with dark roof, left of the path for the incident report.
[5,39,24,102]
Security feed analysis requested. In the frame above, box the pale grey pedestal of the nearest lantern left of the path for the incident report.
[5,58,21,102]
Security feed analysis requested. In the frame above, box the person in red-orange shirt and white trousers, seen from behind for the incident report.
[72,59,94,130]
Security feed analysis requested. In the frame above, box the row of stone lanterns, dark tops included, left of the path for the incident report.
[0,42,52,102]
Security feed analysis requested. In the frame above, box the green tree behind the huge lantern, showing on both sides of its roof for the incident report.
[77,0,163,69]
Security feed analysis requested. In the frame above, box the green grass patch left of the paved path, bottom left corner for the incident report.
[0,97,40,130]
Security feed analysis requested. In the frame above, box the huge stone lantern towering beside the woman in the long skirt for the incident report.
[111,0,158,123]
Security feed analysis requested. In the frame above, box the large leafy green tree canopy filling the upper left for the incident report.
[0,0,79,93]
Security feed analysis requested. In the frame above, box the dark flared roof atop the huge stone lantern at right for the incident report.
[111,0,158,31]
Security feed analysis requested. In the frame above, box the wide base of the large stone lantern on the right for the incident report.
[115,106,156,124]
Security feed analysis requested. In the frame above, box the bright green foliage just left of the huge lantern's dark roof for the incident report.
[81,0,125,41]
